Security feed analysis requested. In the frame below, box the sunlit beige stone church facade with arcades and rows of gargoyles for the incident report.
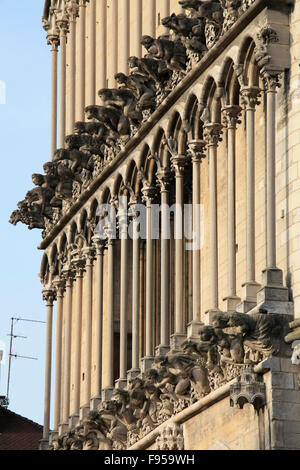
[11,0,300,450]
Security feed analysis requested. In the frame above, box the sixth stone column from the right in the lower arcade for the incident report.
[171,155,188,350]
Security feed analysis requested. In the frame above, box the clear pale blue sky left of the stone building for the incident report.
[0,0,51,424]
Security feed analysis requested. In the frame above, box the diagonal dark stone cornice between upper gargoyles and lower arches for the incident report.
[38,0,288,250]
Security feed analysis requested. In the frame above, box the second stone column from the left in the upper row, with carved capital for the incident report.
[57,12,69,148]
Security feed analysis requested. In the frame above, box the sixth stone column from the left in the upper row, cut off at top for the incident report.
[97,0,107,90]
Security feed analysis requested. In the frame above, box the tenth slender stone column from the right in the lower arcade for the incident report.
[117,196,128,388]
